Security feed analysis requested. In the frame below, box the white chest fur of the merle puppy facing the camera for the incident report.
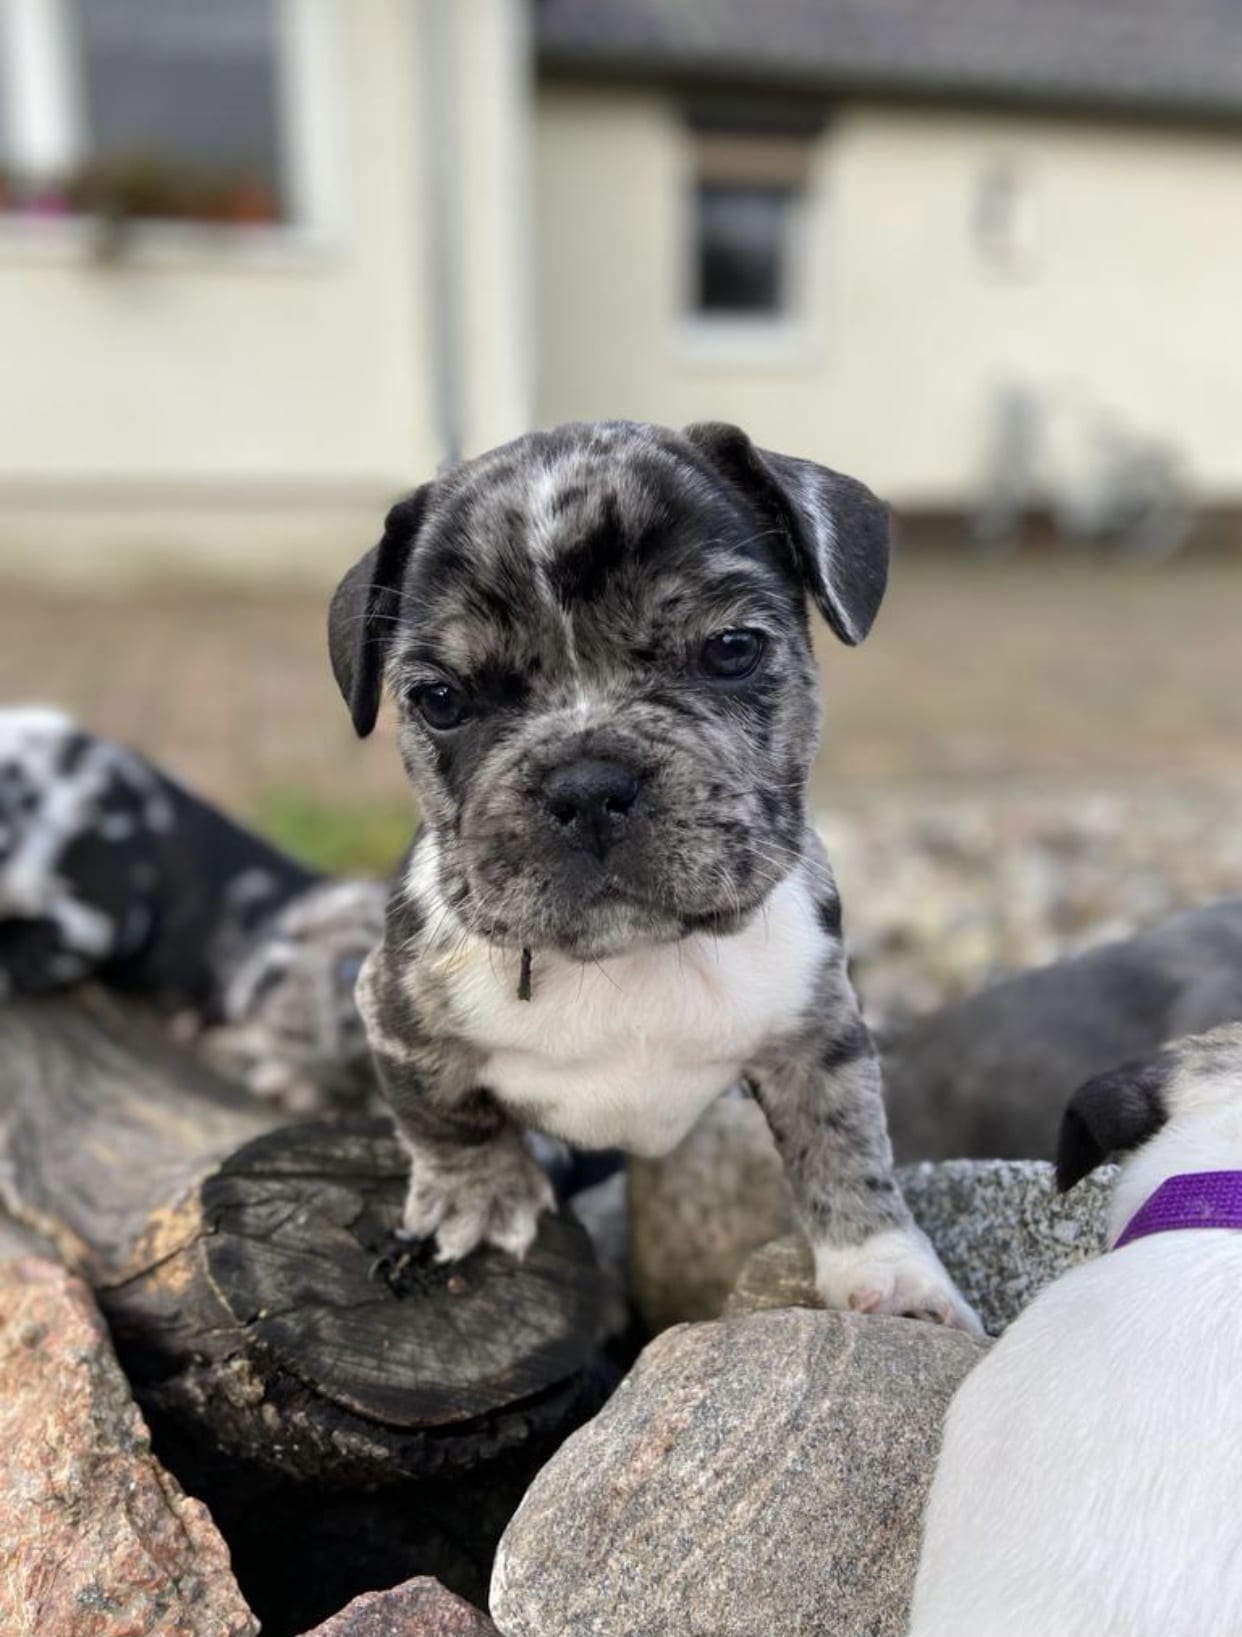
[435,873,825,1154]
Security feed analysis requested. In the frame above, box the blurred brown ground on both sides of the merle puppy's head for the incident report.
[0,553,1242,863]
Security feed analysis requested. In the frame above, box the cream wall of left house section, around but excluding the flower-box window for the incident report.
[0,0,530,576]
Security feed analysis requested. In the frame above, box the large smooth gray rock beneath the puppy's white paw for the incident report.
[491,1311,982,1637]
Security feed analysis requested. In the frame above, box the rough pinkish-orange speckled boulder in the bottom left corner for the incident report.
[0,1257,259,1637]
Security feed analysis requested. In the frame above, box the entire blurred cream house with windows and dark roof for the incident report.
[0,0,1242,573]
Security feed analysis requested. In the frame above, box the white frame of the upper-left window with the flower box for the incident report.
[0,0,345,259]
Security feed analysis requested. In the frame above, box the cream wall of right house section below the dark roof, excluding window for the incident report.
[535,83,1242,506]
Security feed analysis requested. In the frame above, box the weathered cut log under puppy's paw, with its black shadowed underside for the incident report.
[0,990,604,1637]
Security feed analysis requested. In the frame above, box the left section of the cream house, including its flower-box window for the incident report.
[0,0,530,575]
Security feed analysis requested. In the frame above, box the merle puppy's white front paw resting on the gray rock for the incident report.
[815,1224,983,1339]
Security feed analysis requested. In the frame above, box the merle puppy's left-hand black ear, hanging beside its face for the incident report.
[327,483,430,738]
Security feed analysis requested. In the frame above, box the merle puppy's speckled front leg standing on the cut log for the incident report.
[357,951,556,1262]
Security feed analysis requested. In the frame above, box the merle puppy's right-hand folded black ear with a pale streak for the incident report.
[684,421,889,645]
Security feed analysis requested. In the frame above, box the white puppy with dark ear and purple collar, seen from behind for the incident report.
[910,1025,1242,1637]
